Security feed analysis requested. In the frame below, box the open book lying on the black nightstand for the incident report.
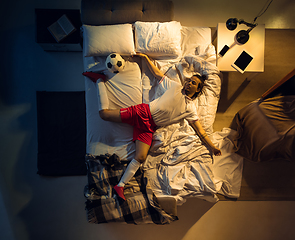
[48,14,76,42]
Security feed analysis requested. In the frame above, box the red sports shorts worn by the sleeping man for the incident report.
[120,103,157,146]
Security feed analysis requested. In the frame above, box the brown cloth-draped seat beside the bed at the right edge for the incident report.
[231,69,295,162]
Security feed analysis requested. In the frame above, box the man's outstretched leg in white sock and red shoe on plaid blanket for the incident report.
[114,140,150,200]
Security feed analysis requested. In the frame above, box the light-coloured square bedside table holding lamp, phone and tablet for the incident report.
[217,23,265,73]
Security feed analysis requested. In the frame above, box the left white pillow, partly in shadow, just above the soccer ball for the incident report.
[83,24,135,57]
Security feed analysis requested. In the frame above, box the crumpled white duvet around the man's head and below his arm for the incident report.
[144,56,243,205]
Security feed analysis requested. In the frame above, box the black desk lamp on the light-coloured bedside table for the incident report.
[226,18,258,44]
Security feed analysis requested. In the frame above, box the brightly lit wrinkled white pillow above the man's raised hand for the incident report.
[134,21,181,57]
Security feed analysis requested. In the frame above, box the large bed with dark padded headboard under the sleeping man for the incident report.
[81,0,243,224]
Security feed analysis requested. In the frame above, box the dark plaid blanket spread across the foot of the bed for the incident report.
[84,154,178,224]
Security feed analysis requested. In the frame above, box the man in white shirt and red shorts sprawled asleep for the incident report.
[84,54,221,200]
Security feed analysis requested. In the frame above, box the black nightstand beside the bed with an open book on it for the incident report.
[35,9,82,52]
